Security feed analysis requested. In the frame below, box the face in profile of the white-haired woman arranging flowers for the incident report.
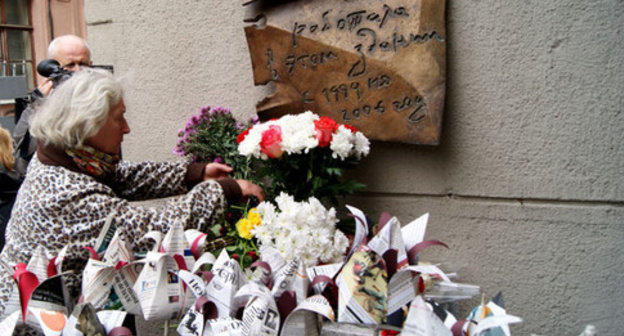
[86,98,130,154]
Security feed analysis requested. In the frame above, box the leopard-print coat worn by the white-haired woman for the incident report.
[0,156,227,321]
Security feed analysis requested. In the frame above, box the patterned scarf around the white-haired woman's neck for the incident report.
[65,146,119,177]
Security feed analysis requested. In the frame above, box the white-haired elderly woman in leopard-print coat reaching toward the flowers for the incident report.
[0,69,264,320]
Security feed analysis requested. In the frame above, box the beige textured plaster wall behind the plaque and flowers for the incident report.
[85,0,624,335]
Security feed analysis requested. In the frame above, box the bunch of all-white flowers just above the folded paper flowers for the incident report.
[250,193,349,267]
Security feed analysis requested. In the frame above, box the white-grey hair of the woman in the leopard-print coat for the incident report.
[30,69,123,149]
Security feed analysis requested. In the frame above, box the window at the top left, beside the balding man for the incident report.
[0,0,35,91]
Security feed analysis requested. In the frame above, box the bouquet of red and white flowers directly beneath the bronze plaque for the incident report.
[237,111,370,205]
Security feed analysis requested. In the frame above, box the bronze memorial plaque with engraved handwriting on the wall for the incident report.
[245,0,446,145]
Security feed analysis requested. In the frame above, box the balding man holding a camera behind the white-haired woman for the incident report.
[13,35,92,179]
